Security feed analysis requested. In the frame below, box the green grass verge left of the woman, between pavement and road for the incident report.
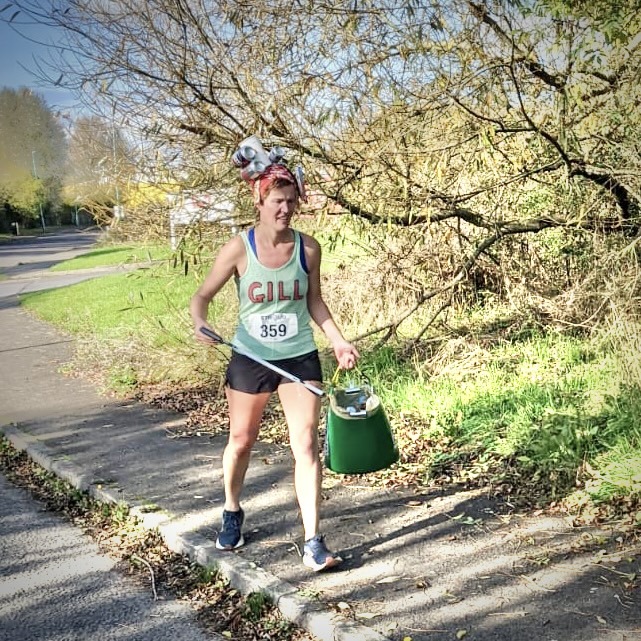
[21,248,233,384]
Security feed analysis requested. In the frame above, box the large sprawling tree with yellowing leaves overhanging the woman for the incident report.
[6,0,641,331]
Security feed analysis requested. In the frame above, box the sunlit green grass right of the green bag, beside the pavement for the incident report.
[361,334,641,501]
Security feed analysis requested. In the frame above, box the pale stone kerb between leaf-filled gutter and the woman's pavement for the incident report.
[0,425,390,641]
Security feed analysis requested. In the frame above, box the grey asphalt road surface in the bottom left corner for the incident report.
[0,475,213,641]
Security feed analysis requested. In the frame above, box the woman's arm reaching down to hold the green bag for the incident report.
[301,234,359,369]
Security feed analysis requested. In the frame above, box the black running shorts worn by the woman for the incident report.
[225,350,323,394]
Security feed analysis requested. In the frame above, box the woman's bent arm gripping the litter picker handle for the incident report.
[189,236,247,343]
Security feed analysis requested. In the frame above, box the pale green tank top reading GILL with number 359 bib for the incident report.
[234,230,316,361]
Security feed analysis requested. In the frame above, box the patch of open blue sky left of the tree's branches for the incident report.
[0,14,80,111]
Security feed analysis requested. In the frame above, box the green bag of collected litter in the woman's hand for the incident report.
[325,370,399,474]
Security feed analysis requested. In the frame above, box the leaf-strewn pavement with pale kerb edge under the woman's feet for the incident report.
[0,232,641,641]
